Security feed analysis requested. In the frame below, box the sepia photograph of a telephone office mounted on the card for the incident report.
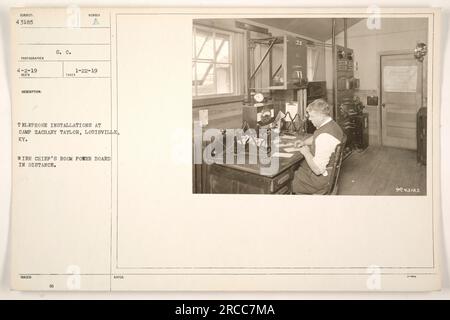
[192,16,430,196]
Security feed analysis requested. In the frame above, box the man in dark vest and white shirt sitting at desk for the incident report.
[293,99,344,194]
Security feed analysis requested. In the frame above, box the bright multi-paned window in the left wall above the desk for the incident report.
[192,26,243,98]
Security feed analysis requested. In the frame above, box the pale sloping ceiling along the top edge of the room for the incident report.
[248,18,361,41]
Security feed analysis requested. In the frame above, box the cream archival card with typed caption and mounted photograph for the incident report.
[10,6,441,292]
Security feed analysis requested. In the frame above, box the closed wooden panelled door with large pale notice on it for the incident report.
[380,53,422,150]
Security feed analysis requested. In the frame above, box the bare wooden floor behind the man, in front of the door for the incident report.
[338,146,426,195]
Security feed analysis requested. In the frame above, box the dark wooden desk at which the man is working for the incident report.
[206,136,305,194]
